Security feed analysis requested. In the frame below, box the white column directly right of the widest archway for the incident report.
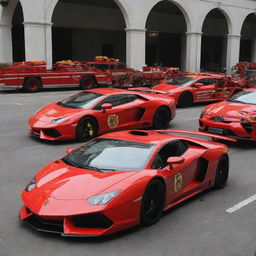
[125,28,146,69]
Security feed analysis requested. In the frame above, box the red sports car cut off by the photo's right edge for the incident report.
[199,88,256,141]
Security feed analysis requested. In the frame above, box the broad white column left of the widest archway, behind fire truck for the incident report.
[23,21,52,68]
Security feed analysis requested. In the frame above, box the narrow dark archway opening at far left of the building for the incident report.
[12,2,25,61]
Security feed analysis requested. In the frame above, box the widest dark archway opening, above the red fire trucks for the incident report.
[52,0,126,62]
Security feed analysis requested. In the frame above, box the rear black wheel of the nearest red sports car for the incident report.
[214,155,229,189]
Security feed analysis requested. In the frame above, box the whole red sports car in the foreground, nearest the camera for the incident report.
[20,130,232,236]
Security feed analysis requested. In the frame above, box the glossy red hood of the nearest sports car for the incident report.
[31,160,137,200]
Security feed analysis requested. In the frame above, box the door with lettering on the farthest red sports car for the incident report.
[193,78,216,102]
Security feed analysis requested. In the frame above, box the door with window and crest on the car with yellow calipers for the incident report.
[95,94,145,132]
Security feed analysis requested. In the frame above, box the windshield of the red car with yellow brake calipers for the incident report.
[58,91,104,109]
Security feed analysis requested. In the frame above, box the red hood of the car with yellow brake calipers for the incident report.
[31,102,85,122]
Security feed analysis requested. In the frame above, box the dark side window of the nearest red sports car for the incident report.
[151,140,188,169]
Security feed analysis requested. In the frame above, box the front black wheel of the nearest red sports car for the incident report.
[140,179,165,226]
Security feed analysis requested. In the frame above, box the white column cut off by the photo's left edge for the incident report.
[0,24,13,63]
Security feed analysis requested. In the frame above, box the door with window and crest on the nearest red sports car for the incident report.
[152,140,205,204]
